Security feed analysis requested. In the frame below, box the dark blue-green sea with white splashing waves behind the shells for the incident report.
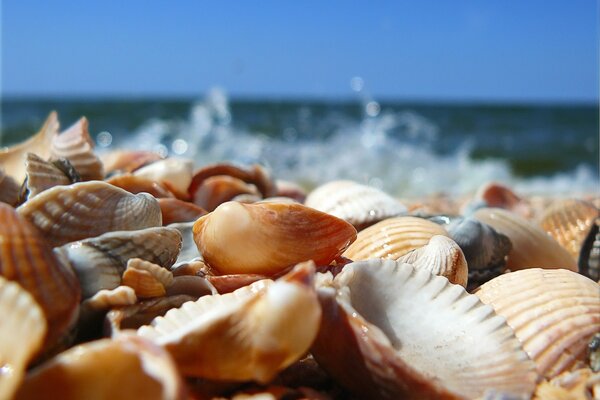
[0,90,600,196]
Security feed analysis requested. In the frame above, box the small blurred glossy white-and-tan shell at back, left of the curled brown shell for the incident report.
[134,158,194,197]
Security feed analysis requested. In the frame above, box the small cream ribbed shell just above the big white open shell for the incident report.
[397,235,468,287]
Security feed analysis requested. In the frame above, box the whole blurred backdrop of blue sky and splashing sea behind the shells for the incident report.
[0,0,600,196]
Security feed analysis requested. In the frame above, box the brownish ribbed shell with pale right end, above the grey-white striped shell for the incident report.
[17,181,162,246]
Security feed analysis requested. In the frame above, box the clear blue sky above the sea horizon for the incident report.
[1,0,599,102]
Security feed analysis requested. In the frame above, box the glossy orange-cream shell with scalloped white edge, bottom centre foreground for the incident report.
[137,263,321,383]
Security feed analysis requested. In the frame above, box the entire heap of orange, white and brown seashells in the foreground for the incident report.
[0,113,600,400]
